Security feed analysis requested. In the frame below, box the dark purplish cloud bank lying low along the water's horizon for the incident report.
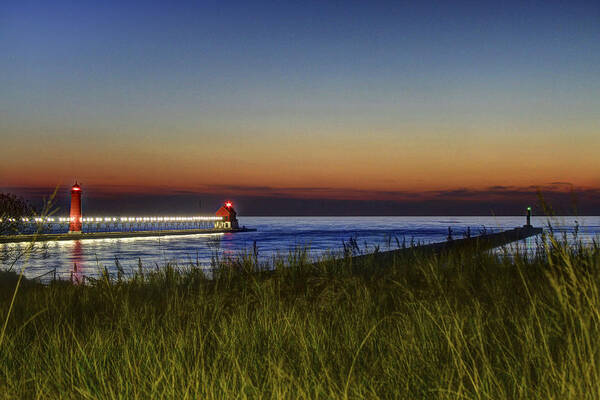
[0,184,600,215]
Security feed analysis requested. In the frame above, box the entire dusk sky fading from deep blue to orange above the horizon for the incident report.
[0,0,600,215]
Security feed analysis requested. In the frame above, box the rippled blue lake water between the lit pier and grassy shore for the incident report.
[0,217,600,280]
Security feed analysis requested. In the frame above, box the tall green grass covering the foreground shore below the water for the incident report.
[0,236,600,399]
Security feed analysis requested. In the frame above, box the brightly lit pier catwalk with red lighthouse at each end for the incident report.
[59,182,239,234]
